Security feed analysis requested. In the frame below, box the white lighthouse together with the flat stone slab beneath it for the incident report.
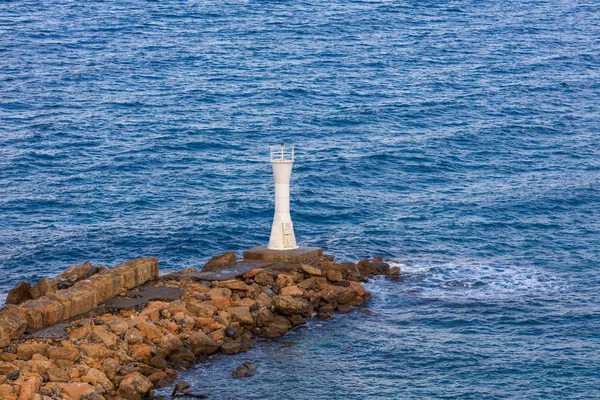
[244,142,323,264]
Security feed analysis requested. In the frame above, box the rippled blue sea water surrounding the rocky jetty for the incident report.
[0,0,600,399]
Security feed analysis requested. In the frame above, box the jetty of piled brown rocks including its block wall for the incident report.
[0,254,398,400]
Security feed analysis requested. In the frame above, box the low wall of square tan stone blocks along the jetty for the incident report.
[0,257,158,347]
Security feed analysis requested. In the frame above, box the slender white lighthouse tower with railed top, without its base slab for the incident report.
[267,142,298,250]
